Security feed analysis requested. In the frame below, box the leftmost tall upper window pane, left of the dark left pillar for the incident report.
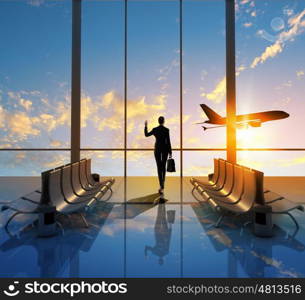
[0,0,71,150]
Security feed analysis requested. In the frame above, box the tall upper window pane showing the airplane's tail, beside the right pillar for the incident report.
[183,0,226,148]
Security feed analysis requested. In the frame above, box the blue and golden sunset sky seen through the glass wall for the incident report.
[0,0,305,176]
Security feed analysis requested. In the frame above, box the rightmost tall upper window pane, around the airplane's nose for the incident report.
[236,0,305,148]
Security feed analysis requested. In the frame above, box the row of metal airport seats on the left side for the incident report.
[1,158,114,234]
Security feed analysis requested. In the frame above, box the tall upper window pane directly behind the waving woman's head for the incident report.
[127,0,180,148]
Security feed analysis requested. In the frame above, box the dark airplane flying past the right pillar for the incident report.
[195,104,289,130]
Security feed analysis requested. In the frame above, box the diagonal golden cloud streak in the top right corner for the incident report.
[251,9,305,69]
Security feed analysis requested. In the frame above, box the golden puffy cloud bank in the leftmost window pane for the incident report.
[0,90,70,147]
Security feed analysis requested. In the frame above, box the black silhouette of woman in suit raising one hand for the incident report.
[144,116,172,194]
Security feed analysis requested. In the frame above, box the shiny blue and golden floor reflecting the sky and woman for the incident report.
[0,178,305,277]
